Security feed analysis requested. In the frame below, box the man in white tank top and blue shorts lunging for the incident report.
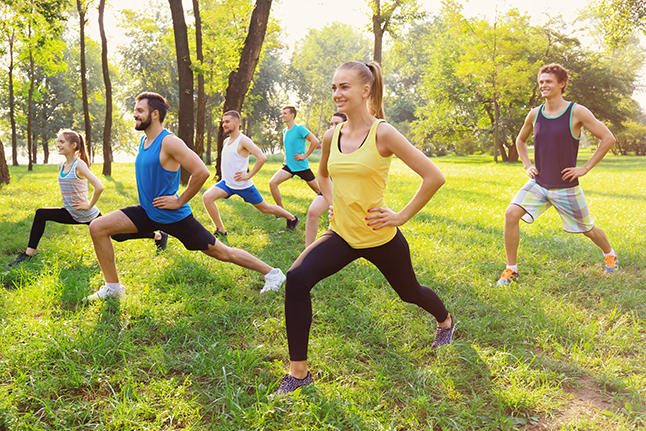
[202,111,299,239]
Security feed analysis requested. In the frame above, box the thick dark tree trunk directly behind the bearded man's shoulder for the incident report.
[168,0,195,184]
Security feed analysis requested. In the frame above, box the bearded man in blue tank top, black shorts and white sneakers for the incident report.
[85,93,285,301]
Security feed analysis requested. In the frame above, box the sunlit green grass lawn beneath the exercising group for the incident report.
[0,155,646,431]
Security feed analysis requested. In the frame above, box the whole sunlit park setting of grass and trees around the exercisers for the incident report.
[0,0,646,430]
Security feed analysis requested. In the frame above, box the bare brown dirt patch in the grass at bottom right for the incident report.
[526,376,618,431]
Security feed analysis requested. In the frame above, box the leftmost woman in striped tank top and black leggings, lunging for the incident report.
[9,129,168,266]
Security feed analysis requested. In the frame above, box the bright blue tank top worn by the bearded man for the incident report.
[135,129,192,224]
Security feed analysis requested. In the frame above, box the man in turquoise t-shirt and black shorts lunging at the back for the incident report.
[269,106,320,207]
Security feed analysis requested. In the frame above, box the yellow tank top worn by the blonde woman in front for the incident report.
[327,120,397,248]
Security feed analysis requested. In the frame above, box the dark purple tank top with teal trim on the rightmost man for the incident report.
[534,102,580,189]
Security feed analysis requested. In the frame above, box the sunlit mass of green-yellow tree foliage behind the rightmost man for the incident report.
[404,2,644,160]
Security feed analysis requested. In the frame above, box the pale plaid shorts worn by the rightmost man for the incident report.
[511,179,594,233]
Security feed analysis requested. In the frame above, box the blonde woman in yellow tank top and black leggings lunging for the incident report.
[276,61,455,395]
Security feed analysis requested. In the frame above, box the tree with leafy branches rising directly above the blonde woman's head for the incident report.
[368,0,423,64]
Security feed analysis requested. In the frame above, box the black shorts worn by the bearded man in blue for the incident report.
[121,205,215,250]
